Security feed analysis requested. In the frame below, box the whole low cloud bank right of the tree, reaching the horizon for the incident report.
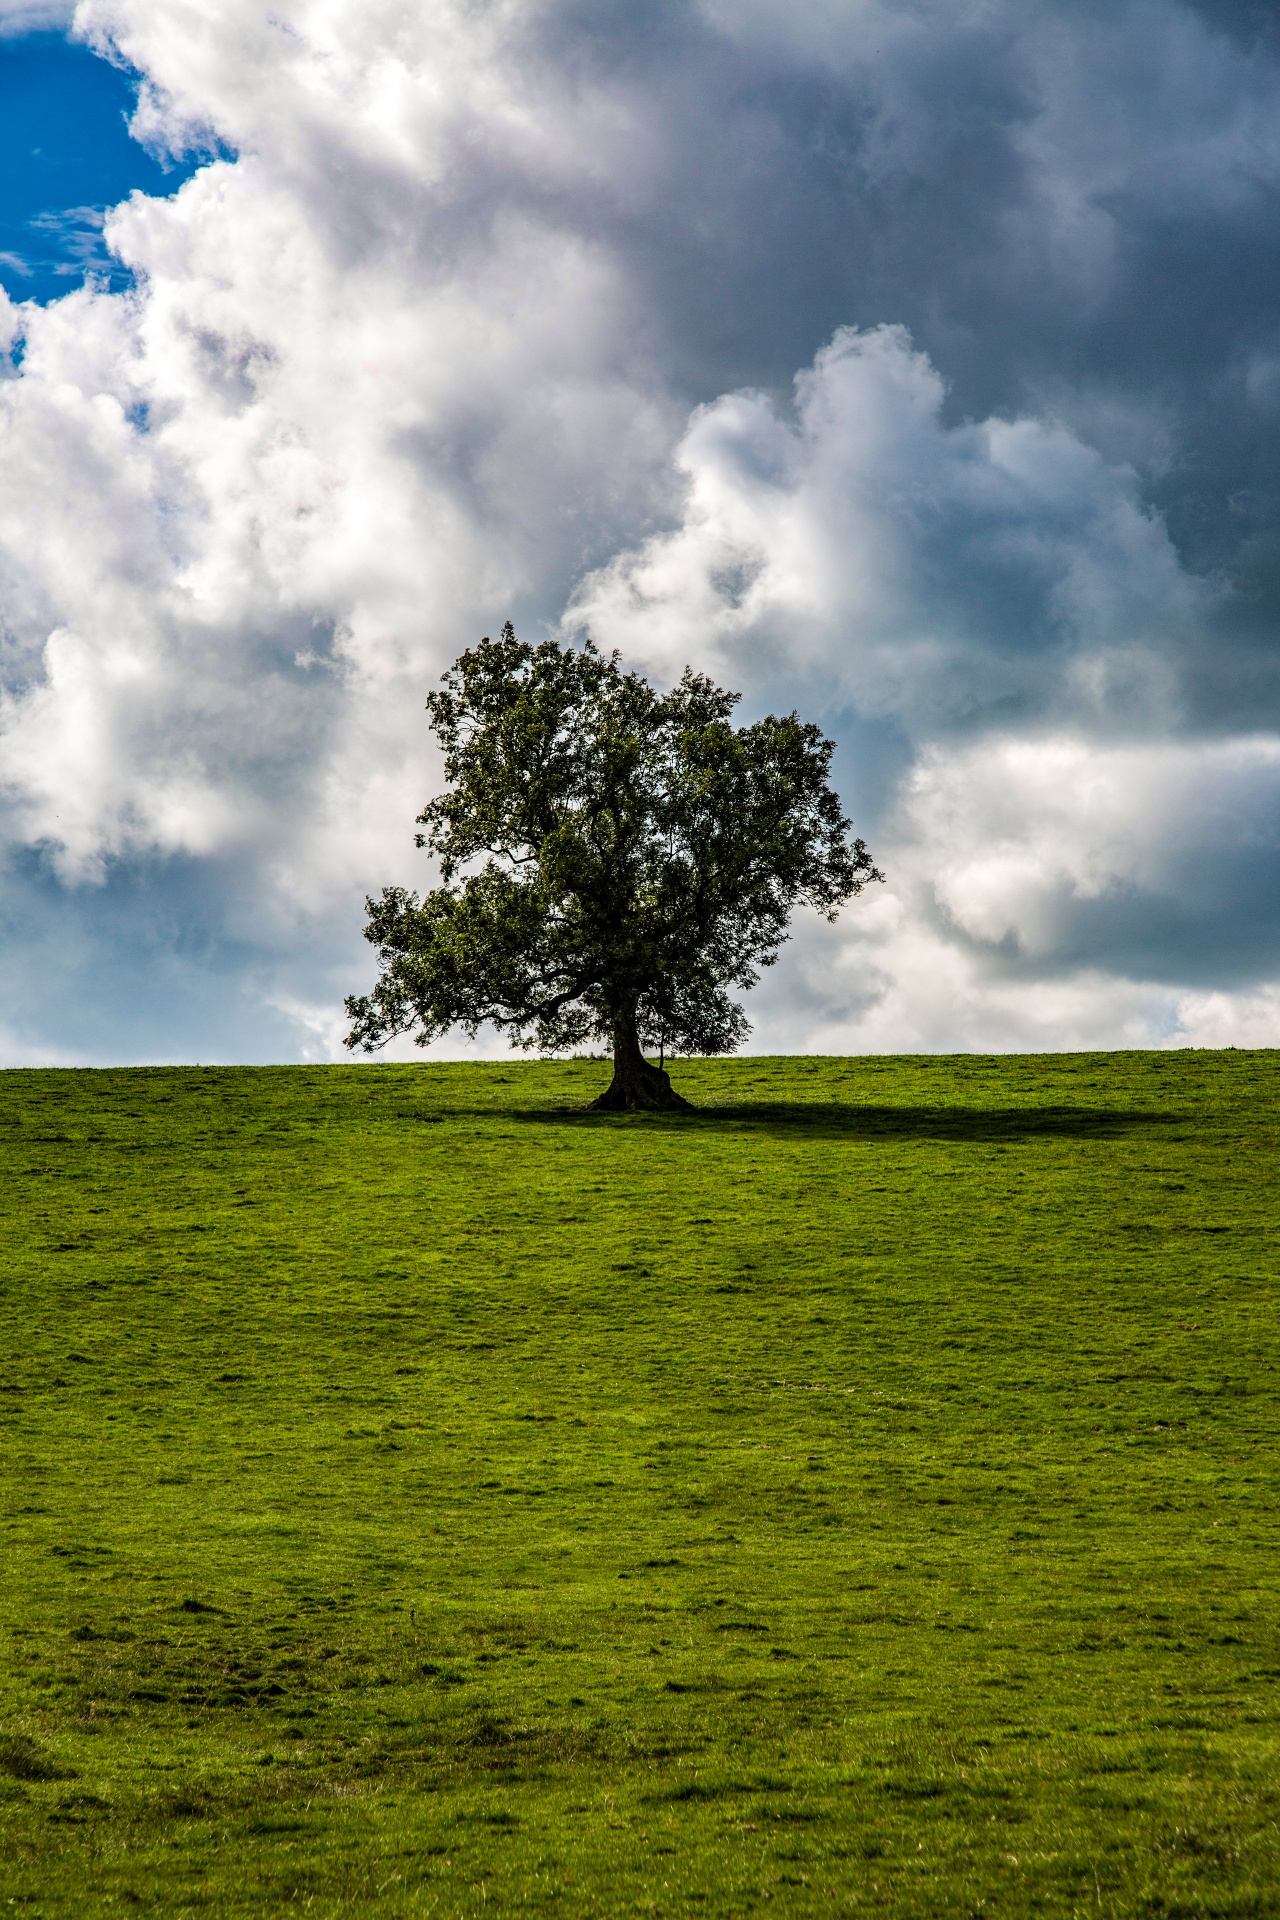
[725,733,1280,1052]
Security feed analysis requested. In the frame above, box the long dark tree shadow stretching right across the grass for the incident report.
[489,1100,1192,1144]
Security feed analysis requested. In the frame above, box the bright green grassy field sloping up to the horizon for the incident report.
[0,1052,1280,1920]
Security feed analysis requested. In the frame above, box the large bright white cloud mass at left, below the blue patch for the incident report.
[0,161,675,877]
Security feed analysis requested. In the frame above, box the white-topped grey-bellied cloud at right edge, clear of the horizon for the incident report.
[904,735,1280,985]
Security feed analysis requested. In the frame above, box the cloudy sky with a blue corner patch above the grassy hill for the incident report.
[0,0,1280,1066]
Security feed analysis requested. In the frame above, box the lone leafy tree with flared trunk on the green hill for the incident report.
[347,622,881,1112]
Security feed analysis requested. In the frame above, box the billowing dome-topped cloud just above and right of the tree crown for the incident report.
[570,326,1213,735]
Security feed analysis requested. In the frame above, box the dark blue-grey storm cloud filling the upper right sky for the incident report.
[416,0,1280,726]
